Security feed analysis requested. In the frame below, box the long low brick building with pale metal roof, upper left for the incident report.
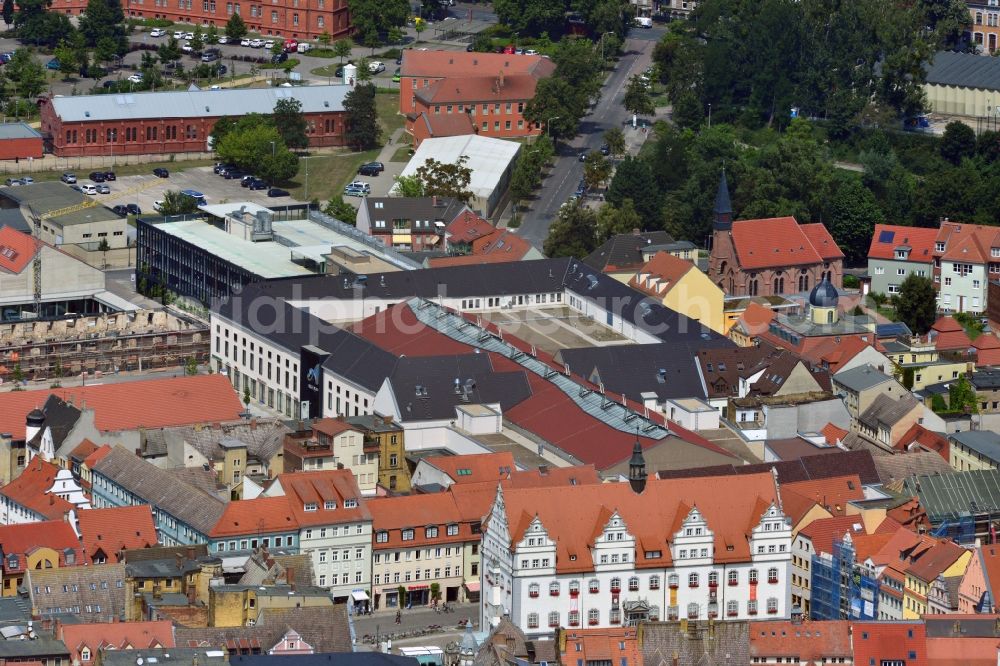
[39,85,350,157]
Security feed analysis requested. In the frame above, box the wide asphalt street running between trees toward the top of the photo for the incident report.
[518,27,666,248]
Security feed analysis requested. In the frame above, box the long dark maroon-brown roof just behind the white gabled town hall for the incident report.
[657,451,882,485]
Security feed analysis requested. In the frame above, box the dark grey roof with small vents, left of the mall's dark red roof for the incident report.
[389,354,531,421]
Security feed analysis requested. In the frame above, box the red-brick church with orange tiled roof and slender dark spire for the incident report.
[708,171,844,296]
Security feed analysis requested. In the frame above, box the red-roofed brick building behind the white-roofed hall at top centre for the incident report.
[399,49,555,147]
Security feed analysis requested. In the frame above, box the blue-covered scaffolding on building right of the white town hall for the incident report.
[810,535,880,620]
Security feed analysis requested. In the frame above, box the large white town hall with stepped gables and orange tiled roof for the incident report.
[480,451,792,636]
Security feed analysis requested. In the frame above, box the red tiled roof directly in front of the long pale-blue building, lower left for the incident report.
[77,504,157,564]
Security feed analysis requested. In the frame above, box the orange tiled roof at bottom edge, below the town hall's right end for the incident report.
[750,620,852,666]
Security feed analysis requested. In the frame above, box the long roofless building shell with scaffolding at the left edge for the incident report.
[0,310,211,381]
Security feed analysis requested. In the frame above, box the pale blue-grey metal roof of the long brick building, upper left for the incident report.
[52,85,352,122]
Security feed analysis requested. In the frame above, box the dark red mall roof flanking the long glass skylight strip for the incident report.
[352,304,733,469]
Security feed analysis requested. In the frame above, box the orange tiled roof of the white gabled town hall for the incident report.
[504,472,777,573]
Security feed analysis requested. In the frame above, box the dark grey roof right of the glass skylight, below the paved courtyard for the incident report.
[556,338,735,403]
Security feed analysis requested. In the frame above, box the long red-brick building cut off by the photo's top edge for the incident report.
[120,0,353,39]
